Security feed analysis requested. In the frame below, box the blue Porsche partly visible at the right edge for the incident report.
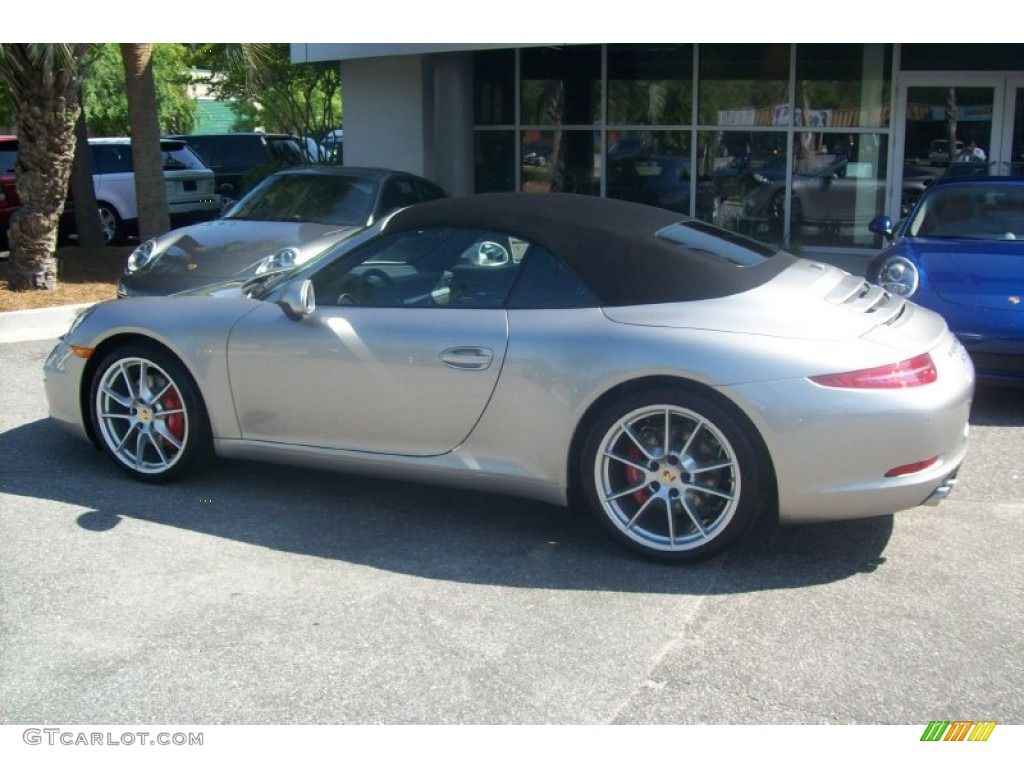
[866,176,1024,383]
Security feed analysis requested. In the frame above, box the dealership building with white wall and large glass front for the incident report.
[292,43,1024,262]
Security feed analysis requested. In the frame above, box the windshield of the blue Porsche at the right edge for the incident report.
[906,183,1024,240]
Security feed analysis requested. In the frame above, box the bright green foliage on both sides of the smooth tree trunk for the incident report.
[83,43,196,136]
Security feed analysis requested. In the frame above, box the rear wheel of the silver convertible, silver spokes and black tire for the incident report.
[580,389,772,562]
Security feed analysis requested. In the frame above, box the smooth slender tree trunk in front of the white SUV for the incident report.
[121,43,171,241]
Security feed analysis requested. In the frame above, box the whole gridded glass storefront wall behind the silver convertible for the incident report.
[474,43,905,248]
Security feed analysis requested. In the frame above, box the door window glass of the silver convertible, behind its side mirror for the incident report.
[313,228,520,309]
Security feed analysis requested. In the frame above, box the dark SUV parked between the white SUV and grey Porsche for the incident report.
[167,132,309,200]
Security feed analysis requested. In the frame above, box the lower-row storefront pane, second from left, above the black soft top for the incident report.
[519,130,601,195]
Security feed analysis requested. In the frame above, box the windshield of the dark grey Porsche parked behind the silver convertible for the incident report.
[224,173,377,226]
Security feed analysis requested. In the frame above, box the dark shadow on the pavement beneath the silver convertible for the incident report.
[0,420,893,595]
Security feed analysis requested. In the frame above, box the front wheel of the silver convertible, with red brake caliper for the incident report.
[89,345,211,482]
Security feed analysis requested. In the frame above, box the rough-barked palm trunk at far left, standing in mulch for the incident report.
[0,43,89,291]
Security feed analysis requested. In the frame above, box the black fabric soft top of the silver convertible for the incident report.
[385,193,797,306]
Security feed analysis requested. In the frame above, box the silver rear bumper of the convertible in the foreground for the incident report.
[724,335,974,523]
